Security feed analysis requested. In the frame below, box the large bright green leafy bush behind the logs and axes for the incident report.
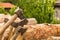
[0,0,55,23]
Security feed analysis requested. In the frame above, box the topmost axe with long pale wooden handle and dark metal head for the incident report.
[0,7,23,35]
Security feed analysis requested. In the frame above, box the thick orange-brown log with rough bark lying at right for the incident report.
[23,24,60,40]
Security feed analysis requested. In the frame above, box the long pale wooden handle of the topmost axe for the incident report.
[0,14,17,35]
